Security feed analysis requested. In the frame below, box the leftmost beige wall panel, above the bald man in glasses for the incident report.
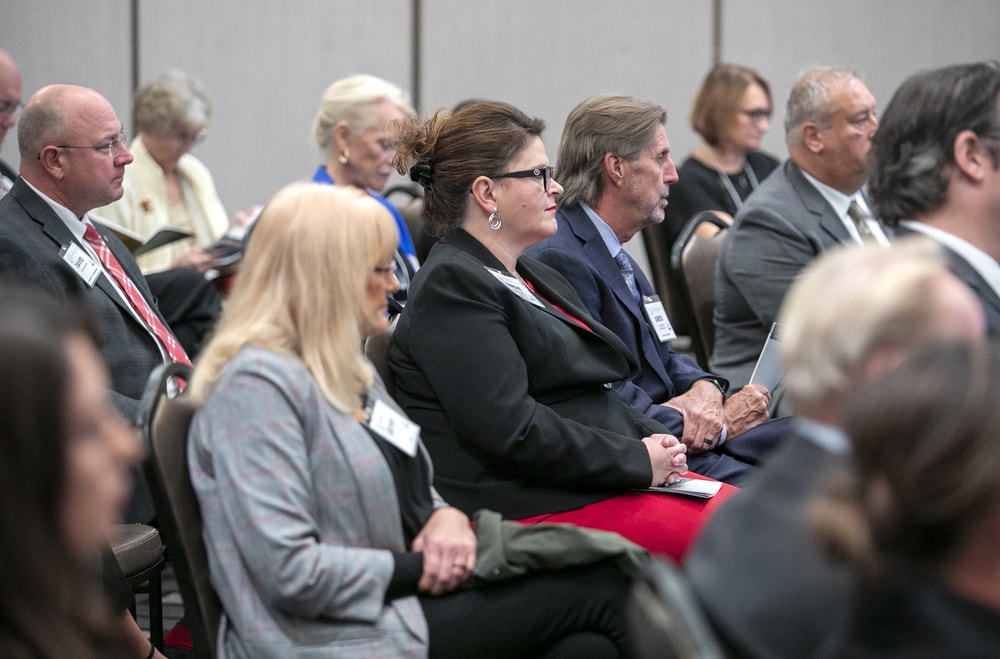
[0,0,130,167]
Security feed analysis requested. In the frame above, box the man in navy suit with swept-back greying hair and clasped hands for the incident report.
[528,94,783,485]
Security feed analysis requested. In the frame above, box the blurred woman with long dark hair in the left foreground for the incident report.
[0,288,146,659]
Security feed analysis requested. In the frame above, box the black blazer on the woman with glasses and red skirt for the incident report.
[390,230,667,518]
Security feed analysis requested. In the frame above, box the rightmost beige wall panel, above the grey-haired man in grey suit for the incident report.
[722,0,1000,158]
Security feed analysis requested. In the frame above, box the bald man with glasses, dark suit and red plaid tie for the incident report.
[0,85,186,522]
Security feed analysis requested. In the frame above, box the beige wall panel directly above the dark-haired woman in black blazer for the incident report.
[421,0,712,265]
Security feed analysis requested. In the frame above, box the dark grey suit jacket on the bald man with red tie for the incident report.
[0,178,166,423]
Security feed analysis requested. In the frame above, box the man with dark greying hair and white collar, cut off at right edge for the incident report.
[869,62,1000,334]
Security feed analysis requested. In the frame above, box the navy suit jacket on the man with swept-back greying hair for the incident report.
[527,204,712,437]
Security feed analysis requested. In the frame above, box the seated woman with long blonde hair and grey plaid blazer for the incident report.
[188,183,628,659]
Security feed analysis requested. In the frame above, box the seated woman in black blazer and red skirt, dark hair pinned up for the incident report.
[390,102,733,559]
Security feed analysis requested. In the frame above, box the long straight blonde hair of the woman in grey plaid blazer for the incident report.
[191,183,399,412]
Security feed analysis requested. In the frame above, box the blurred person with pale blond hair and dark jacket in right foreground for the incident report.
[685,238,986,658]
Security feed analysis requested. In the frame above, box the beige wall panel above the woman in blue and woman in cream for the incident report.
[139,0,411,214]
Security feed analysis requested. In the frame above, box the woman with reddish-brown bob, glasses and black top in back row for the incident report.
[663,64,778,248]
